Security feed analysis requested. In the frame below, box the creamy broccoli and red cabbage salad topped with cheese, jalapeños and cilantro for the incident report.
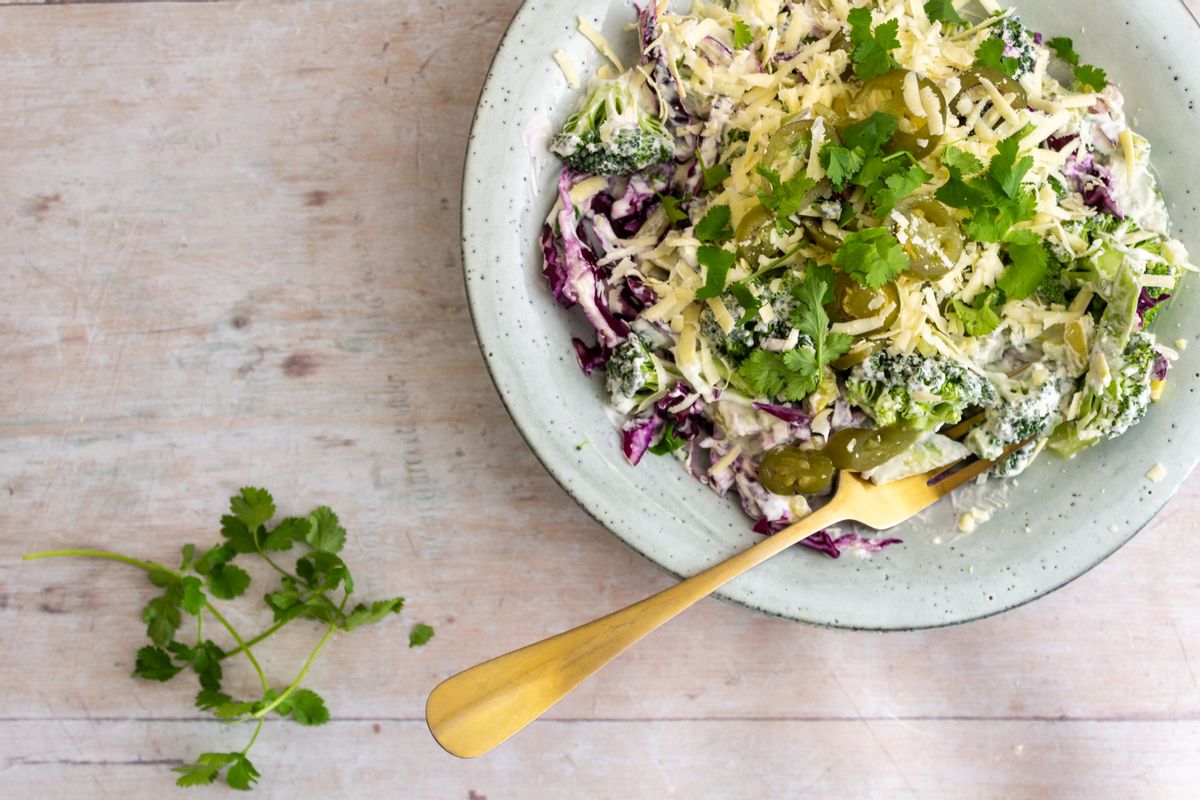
[541,0,1194,555]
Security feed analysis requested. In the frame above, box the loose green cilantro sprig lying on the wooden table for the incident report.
[25,487,433,790]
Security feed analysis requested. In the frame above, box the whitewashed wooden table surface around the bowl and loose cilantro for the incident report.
[0,0,1200,800]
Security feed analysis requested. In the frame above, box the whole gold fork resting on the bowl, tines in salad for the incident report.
[425,420,1027,758]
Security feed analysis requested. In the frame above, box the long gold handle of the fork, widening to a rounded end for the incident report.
[425,506,845,758]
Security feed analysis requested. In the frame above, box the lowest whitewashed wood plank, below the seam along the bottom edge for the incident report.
[0,721,1200,800]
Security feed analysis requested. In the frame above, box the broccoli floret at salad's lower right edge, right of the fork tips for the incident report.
[1050,331,1158,458]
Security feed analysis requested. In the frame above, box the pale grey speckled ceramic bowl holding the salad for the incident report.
[462,0,1200,631]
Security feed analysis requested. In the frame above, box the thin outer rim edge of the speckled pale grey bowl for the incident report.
[460,0,1200,633]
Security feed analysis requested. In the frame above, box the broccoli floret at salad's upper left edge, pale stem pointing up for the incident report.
[550,73,674,175]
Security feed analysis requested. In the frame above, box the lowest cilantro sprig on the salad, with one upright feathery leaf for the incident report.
[737,263,853,403]
